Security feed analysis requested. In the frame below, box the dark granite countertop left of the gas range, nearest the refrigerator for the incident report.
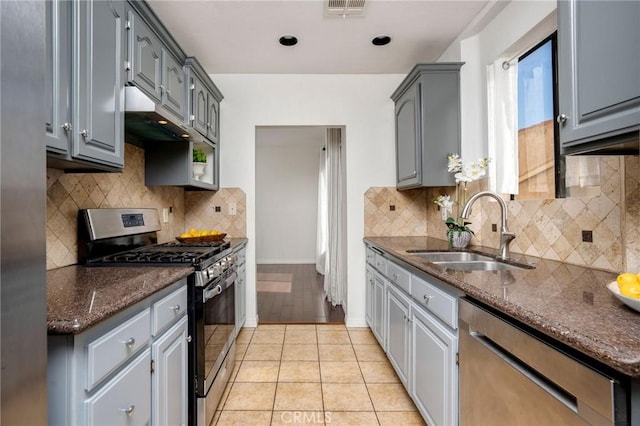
[47,265,193,334]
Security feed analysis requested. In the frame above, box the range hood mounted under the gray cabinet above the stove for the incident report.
[124,86,204,148]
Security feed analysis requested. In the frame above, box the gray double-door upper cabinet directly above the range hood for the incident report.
[127,2,187,120]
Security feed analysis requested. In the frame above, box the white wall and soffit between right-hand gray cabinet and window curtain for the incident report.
[438,0,556,161]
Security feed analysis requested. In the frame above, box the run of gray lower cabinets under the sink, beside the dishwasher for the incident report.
[366,247,459,426]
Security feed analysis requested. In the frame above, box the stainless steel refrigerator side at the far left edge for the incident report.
[0,0,47,426]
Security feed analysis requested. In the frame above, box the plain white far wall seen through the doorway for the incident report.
[256,126,326,264]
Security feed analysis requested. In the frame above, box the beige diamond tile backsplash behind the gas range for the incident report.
[47,144,247,269]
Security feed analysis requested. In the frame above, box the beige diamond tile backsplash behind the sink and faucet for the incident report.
[364,156,640,272]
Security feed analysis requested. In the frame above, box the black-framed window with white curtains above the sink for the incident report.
[488,32,600,200]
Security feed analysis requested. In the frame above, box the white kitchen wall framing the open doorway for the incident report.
[212,74,405,326]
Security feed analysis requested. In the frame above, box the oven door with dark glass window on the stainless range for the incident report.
[196,271,237,397]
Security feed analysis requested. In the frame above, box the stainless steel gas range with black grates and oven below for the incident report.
[78,208,237,426]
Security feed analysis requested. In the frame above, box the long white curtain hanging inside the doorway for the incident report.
[316,128,346,306]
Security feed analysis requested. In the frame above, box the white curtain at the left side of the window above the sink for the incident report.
[487,58,519,194]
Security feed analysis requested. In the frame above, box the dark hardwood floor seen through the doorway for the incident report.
[257,264,344,324]
